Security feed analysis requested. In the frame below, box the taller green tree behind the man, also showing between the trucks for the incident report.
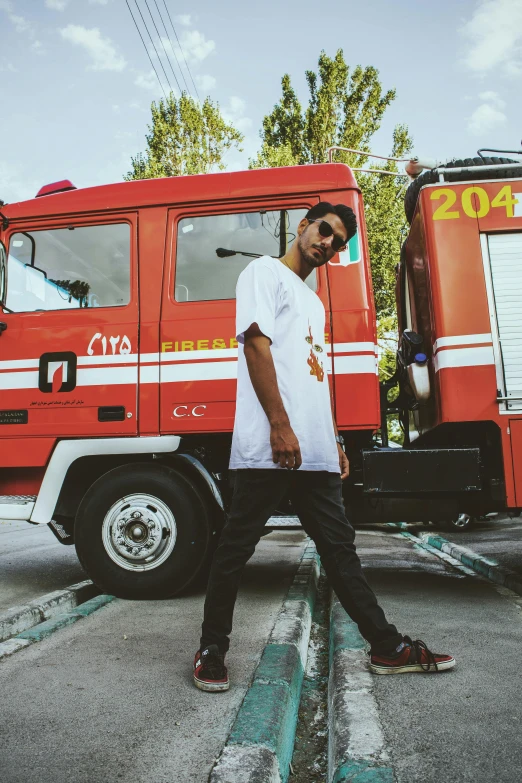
[250,49,412,318]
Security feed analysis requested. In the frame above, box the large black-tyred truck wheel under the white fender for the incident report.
[75,463,211,599]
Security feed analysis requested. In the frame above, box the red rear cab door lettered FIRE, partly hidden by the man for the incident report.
[160,202,316,433]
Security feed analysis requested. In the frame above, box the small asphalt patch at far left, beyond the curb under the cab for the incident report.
[0,520,87,613]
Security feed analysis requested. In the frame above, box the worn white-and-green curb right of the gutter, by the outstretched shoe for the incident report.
[327,593,395,783]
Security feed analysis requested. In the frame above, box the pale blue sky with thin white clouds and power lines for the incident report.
[0,0,522,202]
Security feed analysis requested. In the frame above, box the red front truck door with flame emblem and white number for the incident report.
[0,214,138,438]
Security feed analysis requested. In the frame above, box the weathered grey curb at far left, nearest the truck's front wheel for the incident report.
[0,579,100,642]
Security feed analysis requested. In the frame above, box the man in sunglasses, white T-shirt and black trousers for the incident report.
[194,202,455,691]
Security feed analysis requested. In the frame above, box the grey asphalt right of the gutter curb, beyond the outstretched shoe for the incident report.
[358,532,522,783]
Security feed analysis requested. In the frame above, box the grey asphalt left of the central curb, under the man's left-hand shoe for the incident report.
[0,531,305,783]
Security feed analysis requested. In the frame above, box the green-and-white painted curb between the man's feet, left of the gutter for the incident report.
[209,542,320,783]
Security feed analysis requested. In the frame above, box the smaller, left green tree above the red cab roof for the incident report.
[124,93,244,180]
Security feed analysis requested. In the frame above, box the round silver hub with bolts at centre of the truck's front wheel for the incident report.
[102,494,177,571]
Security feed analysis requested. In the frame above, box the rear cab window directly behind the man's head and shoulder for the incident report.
[174,209,317,302]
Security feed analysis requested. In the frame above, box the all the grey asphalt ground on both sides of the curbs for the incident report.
[0,519,522,783]
